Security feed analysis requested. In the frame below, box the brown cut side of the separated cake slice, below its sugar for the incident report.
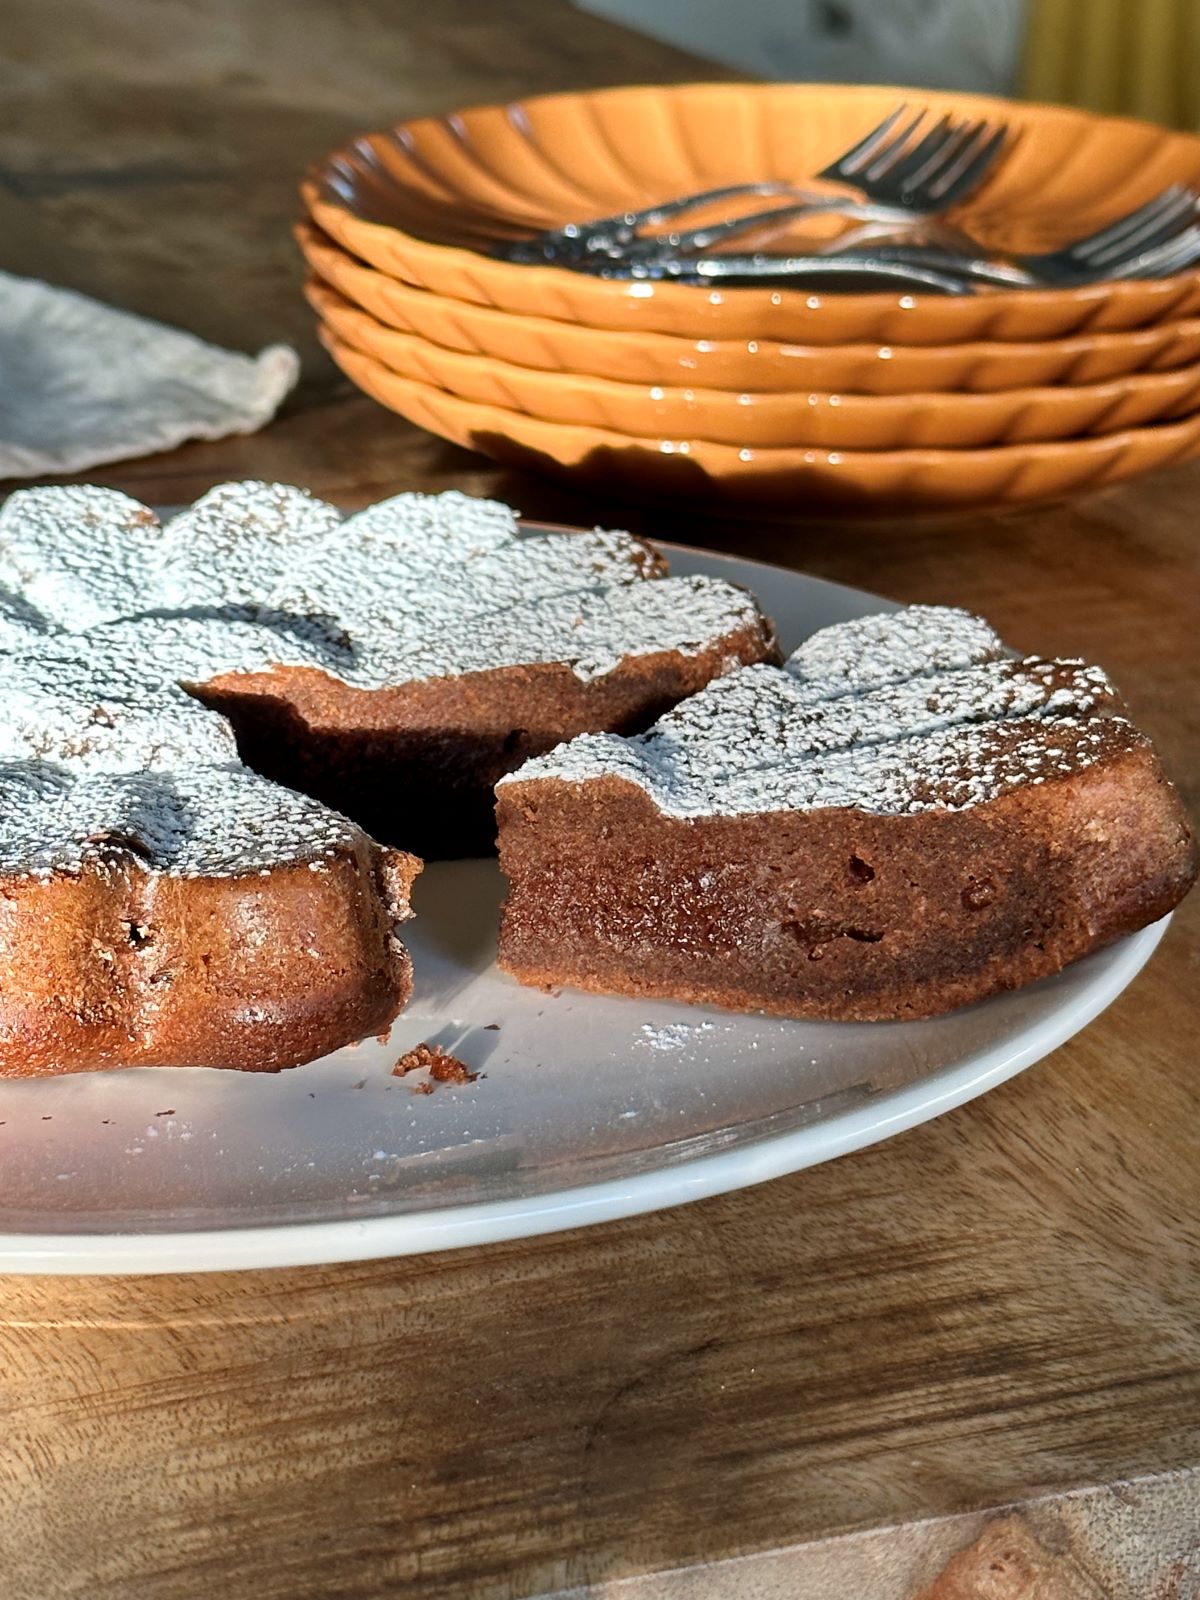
[498,738,1197,1021]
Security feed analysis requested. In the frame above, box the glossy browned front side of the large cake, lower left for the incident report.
[0,838,421,1077]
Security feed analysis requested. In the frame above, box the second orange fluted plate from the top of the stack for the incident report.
[296,222,1200,395]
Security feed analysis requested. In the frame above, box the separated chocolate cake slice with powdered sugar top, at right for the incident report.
[498,606,1197,1019]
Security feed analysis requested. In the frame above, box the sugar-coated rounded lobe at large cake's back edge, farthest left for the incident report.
[0,485,162,632]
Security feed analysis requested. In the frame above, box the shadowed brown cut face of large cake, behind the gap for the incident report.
[192,619,778,858]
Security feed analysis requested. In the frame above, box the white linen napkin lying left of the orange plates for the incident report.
[0,272,299,478]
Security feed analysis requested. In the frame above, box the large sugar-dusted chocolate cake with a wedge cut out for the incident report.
[0,483,773,1075]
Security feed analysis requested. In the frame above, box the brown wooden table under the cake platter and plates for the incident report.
[0,0,1200,1600]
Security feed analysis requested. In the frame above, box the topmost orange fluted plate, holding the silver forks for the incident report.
[304,83,1200,344]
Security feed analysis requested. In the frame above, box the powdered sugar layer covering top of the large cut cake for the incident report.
[0,482,760,875]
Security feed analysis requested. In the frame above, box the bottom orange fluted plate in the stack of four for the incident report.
[322,326,1200,515]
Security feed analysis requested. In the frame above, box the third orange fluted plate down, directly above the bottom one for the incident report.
[306,280,1200,450]
